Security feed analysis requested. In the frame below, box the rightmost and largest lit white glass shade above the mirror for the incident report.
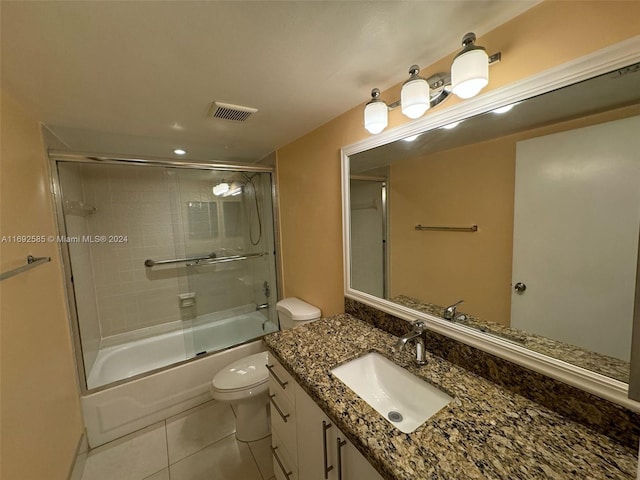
[451,48,489,98]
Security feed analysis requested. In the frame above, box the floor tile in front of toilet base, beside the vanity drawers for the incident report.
[169,435,262,480]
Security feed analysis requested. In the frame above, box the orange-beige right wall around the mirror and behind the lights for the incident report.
[277,1,640,315]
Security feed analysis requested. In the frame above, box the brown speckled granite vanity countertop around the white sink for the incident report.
[264,314,637,480]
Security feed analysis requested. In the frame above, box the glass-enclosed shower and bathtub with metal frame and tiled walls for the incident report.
[50,154,279,392]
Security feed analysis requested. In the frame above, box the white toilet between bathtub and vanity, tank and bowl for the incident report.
[210,297,321,442]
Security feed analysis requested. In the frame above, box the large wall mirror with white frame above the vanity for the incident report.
[343,39,640,403]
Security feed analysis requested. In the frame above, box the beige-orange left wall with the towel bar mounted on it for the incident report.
[0,93,83,480]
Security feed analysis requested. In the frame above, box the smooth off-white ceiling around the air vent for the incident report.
[0,0,539,162]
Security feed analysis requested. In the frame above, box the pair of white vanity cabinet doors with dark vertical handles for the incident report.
[295,384,382,480]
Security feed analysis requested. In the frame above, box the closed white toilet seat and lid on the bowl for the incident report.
[211,352,269,400]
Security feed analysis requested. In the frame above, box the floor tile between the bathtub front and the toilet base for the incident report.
[167,401,236,465]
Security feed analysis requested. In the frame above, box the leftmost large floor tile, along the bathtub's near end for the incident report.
[82,422,169,480]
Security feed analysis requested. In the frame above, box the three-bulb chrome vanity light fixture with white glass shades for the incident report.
[364,33,502,135]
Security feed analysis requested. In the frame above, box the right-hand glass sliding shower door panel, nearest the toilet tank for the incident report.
[176,170,278,355]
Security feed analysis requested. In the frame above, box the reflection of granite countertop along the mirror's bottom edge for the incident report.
[389,295,630,383]
